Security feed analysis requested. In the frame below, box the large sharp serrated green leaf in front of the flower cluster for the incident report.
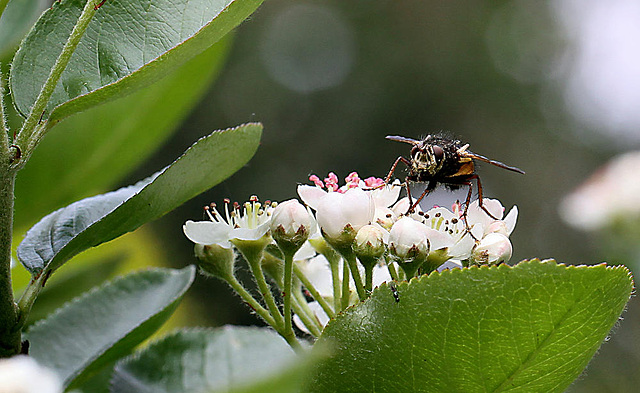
[306,260,633,393]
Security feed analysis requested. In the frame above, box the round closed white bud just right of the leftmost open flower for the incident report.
[270,199,315,253]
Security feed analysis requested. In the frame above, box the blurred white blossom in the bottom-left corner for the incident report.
[0,355,62,393]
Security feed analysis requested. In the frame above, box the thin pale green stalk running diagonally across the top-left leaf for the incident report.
[14,0,100,166]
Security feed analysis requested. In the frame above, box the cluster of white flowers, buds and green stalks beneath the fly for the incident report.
[184,172,518,338]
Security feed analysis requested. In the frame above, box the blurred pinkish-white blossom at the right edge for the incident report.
[559,151,640,231]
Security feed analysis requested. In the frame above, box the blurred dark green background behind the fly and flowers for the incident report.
[6,0,640,392]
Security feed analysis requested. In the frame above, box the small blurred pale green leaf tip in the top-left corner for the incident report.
[0,0,49,58]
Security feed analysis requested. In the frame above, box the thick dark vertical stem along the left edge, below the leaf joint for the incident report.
[0,169,21,358]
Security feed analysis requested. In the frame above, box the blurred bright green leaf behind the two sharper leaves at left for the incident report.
[15,36,231,230]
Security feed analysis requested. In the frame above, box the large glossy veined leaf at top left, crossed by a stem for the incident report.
[10,0,262,124]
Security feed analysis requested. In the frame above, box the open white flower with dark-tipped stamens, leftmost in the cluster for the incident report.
[182,196,273,248]
